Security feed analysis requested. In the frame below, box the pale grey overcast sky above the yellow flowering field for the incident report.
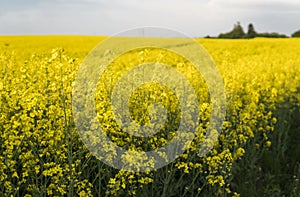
[0,0,300,37]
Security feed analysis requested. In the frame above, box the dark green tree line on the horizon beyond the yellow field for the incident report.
[206,22,300,39]
